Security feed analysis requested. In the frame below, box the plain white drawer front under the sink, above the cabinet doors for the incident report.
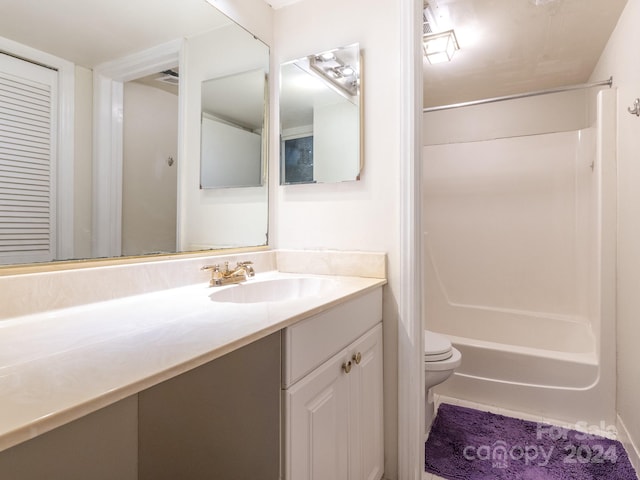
[282,288,382,388]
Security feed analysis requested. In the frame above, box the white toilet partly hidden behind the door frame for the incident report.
[424,330,462,434]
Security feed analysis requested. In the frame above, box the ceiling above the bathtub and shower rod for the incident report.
[423,0,627,107]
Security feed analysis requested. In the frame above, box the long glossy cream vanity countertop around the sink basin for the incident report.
[0,272,386,450]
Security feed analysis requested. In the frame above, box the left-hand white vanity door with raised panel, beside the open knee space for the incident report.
[285,348,349,480]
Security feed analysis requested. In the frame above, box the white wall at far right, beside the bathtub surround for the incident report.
[592,0,640,460]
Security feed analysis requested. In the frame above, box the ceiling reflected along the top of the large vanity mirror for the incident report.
[0,0,231,68]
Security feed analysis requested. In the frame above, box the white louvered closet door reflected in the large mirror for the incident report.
[0,54,57,264]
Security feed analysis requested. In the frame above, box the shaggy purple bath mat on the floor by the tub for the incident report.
[425,404,638,480]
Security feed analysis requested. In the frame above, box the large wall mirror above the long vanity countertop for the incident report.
[0,0,269,265]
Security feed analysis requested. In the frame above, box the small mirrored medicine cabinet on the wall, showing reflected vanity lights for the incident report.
[280,44,362,185]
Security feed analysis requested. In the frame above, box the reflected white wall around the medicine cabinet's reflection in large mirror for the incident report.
[178,25,269,250]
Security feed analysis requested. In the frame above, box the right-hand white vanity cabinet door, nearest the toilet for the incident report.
[349,325,384,480]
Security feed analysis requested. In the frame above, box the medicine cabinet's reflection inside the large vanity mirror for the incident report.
[200,69,268,188]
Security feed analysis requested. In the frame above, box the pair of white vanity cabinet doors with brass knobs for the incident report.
[284,324,384,480]
